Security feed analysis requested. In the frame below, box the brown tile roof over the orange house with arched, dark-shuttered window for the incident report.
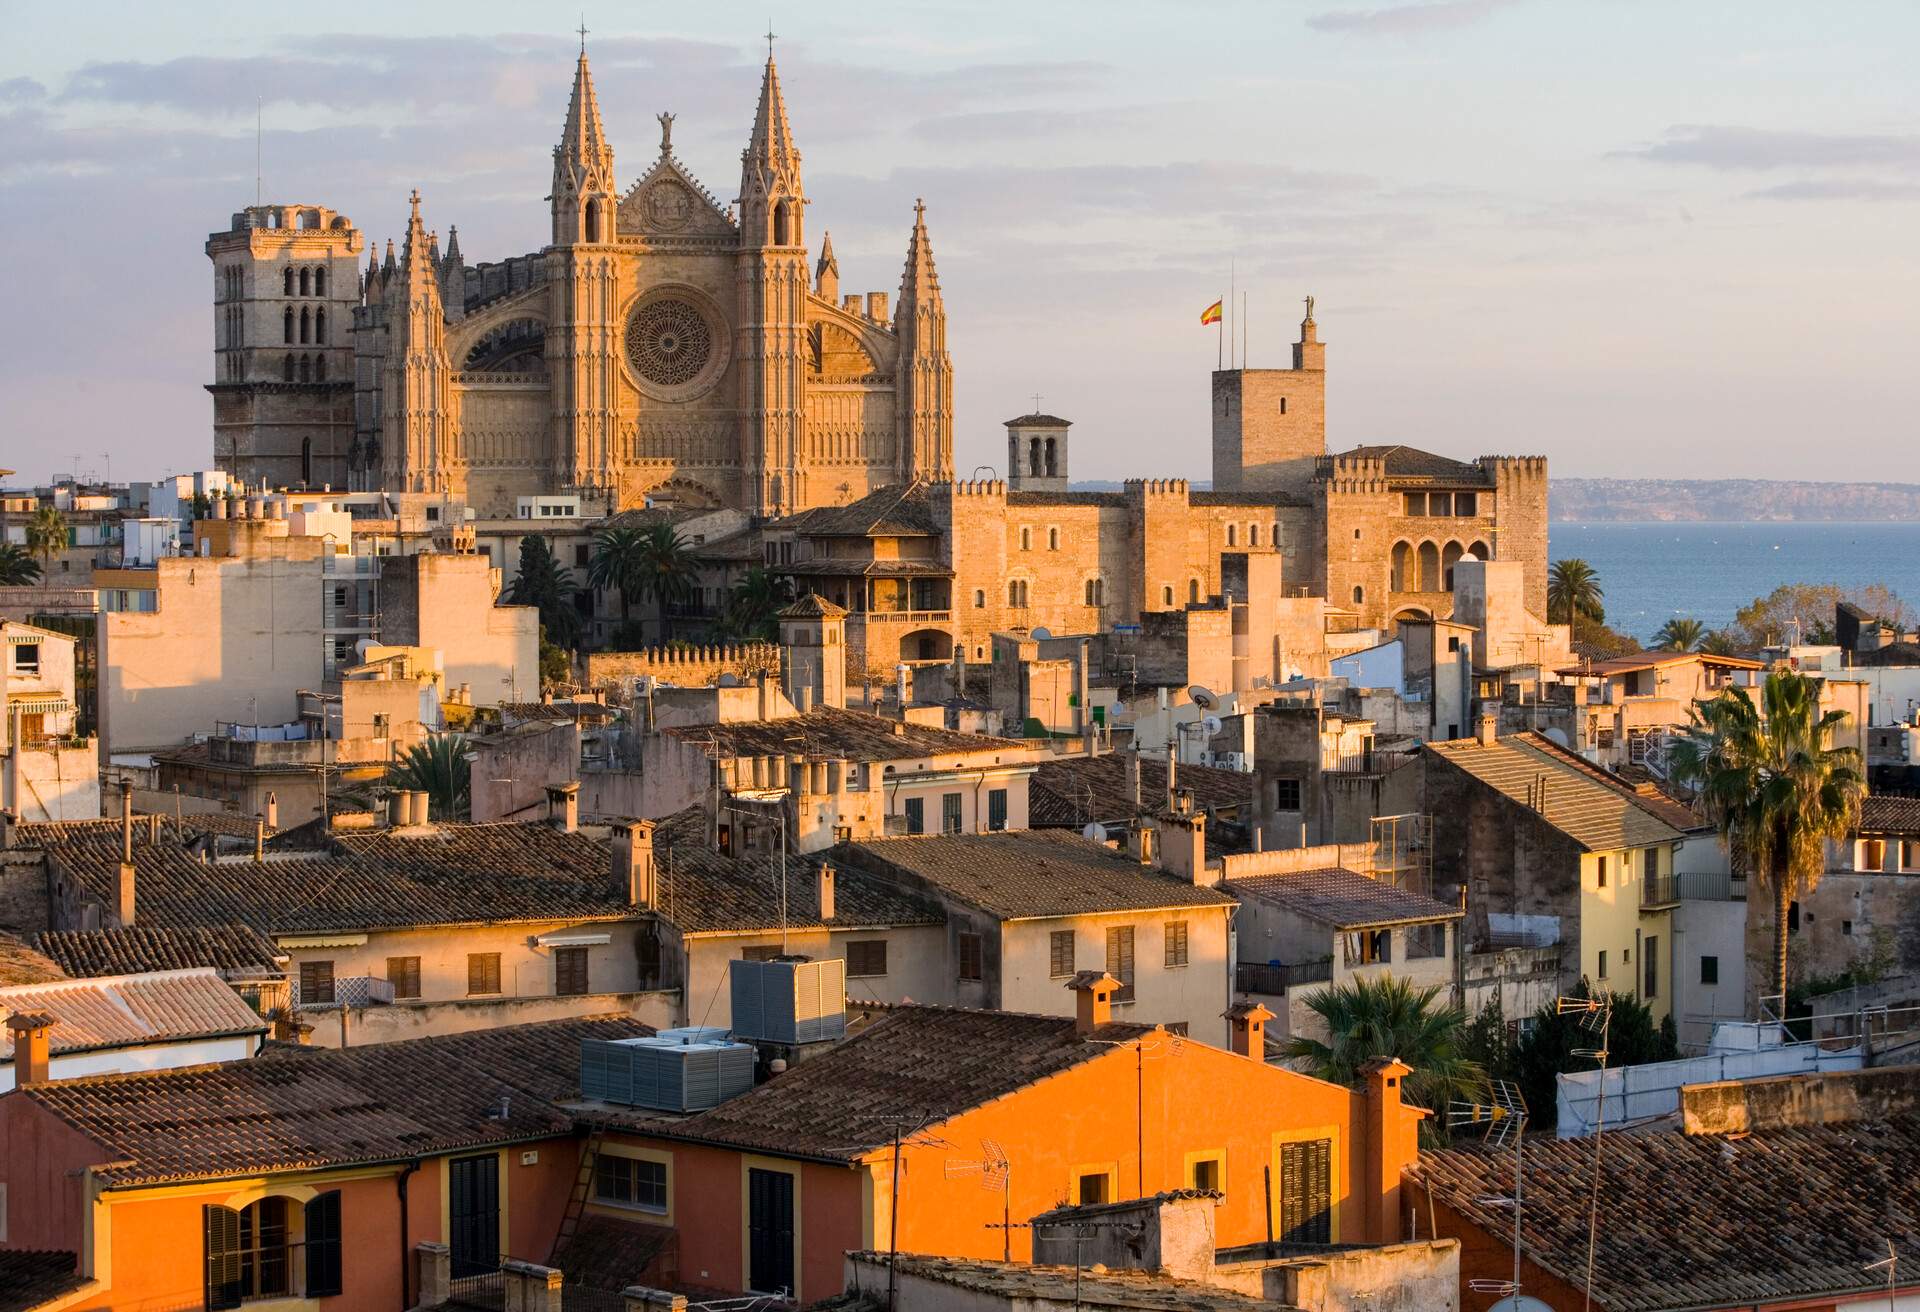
[19,1016,651,1187]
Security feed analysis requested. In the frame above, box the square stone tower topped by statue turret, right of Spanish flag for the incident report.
[1213,298,1327,499]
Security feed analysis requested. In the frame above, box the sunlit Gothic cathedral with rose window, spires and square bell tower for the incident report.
[207,52,952,519]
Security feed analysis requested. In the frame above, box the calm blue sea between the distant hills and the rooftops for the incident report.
[1548,522,1920,640]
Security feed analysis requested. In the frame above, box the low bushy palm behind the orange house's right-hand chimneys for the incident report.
[1281,974,1488,1137]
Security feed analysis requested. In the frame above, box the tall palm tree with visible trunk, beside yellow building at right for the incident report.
[1672,670,1866,1007]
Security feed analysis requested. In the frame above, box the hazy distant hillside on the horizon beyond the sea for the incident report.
[1548,478,1920,524]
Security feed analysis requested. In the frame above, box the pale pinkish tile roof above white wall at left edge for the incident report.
[0,970,267,1060]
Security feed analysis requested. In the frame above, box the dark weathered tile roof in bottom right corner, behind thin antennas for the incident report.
[1411,1118,1920,1312]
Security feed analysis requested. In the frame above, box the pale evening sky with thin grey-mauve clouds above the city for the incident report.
[0,0,1920,482]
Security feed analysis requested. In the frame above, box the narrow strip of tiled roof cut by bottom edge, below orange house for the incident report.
[844,1252,1286,1312]
